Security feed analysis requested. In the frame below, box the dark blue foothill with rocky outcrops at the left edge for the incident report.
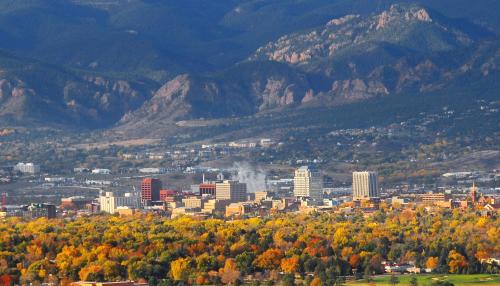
[0,52,156,128]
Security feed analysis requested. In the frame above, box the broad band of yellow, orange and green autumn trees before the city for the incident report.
[0,209,500,285]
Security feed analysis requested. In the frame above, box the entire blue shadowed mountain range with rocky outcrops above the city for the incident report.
[0,0,500,131]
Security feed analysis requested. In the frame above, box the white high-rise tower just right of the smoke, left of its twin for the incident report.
[293,166,323,201]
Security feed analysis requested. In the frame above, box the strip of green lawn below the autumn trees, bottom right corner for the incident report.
[348,274,500,286]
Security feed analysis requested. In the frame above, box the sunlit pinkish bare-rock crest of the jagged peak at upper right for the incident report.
[250,5,480,65]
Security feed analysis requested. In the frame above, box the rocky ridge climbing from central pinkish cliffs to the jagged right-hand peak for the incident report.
[115,5,499,134]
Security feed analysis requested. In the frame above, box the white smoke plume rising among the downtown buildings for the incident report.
[232,162,266,193]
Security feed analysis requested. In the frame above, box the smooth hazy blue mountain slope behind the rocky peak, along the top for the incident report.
[0,0,500,73]
